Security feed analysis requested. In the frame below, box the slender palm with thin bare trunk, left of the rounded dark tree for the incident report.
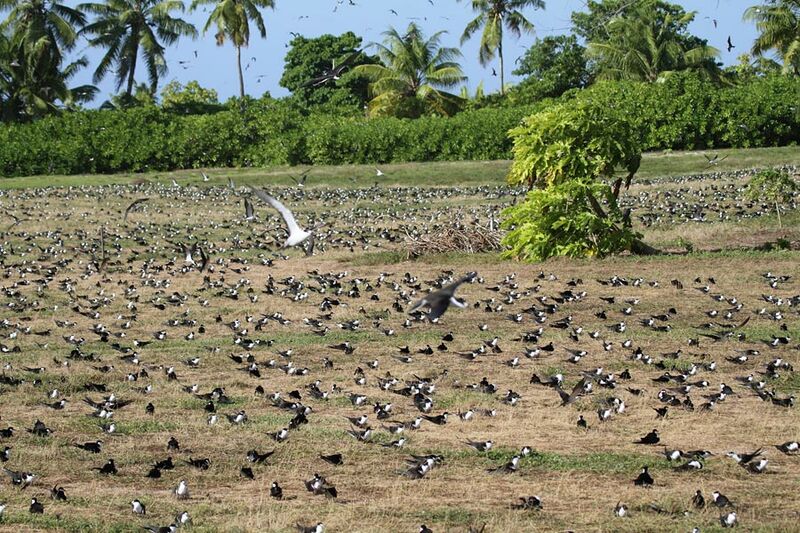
[191,0,275,100]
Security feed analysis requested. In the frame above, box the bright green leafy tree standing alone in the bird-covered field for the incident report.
[503,99,657,261]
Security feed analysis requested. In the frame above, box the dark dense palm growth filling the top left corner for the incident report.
[0,0,97,120]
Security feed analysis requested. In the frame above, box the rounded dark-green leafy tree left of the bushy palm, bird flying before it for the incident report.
[280,32,378,109]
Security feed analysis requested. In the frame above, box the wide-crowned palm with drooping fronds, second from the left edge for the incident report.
[78,0,197,96]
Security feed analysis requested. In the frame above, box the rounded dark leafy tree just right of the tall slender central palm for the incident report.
[513,35,589,100]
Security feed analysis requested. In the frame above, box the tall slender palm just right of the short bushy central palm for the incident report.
[459,0,544,94]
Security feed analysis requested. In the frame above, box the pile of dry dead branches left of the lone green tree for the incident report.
[405,225,502,259]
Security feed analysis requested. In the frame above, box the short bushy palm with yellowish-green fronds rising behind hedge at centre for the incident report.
[353,22,466,117]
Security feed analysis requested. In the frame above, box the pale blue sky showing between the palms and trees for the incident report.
[57,0,759,105]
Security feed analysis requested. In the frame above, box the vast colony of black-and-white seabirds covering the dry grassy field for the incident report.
[0,163,800,533]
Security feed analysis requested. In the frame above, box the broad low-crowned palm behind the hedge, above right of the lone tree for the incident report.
[587,4,719,82]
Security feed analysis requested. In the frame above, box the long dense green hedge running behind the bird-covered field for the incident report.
[0,74,800,176]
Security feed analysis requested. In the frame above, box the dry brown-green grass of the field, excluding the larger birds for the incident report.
[0,148,800,532]
